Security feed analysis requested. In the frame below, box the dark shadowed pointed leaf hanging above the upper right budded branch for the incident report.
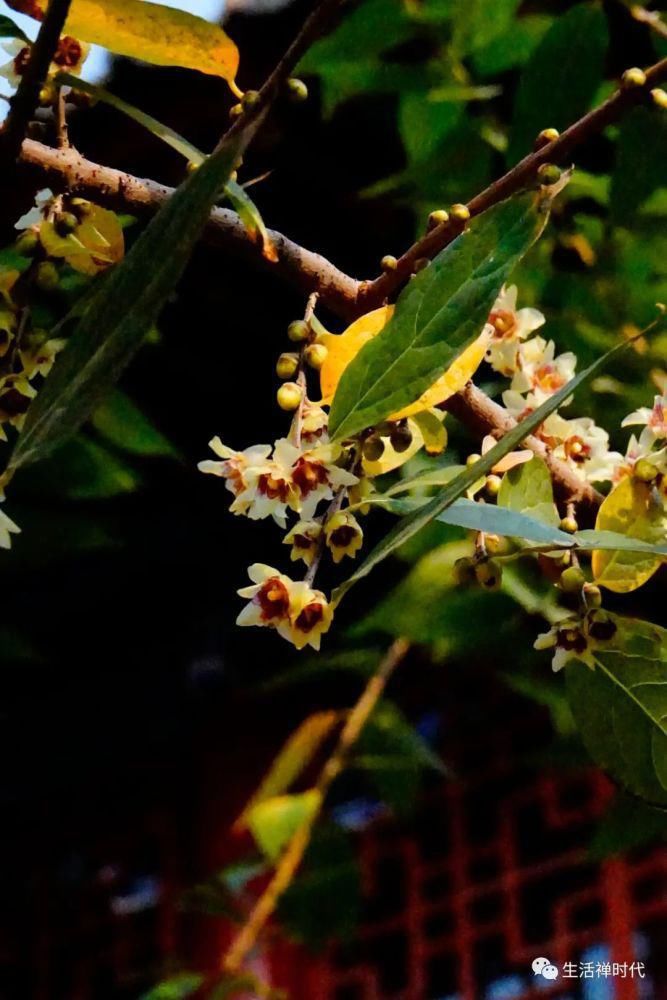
[508,3,608,163]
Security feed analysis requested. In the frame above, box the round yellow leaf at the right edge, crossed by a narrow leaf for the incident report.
[592,476,667,594]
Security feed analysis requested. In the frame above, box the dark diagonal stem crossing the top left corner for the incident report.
[1,0,71,169]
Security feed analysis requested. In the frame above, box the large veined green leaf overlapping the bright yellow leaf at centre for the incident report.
[329,194,548,440]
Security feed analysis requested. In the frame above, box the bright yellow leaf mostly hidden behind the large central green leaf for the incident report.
[319,306,489,420]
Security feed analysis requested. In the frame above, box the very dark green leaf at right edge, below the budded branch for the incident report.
[611,108,667,225]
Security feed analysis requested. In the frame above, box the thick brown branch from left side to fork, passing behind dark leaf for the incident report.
[21,139,366,317]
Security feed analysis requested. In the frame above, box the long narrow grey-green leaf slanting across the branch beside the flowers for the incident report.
[334,338,631,601]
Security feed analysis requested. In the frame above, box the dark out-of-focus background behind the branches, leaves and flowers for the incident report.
[0,0,667,1000]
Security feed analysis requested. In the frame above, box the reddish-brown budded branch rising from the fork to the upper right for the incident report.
[359,53,667,304]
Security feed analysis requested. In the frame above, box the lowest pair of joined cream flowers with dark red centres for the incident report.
[236,563,333,649]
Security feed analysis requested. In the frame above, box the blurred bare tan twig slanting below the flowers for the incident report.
[223,639,410,973]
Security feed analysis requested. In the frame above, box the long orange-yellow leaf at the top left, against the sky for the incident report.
[26,0,239,83]
